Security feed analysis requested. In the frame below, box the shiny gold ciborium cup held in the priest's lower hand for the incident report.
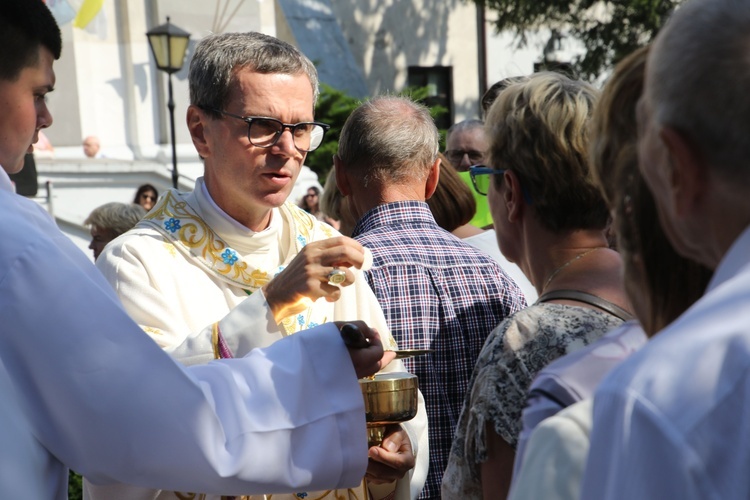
[359,372,418,446]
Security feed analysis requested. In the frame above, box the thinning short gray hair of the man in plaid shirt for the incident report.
[338,96,440,186]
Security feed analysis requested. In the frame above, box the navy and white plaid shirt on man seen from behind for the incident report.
[353,201,526,498]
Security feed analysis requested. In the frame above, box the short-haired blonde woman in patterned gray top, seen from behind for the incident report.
[442,73,631,499]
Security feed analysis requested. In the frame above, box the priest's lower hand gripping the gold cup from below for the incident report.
[365,425,416,484]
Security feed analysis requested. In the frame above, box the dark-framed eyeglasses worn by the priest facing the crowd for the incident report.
[209,108,331,152]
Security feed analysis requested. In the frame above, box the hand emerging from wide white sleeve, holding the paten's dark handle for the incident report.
[334,321,400,378]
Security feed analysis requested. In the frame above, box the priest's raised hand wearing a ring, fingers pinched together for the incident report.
[263,236,371,321]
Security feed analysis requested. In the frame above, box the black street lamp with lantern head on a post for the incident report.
[146,17,190,189]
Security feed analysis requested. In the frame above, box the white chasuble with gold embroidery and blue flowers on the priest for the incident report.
[92,179,428,500]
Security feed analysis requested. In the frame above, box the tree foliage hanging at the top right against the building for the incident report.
[474,0,682,80]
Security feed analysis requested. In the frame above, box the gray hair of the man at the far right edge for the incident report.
[646,0,750,180]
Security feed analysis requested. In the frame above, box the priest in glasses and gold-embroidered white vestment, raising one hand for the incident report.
[85,33,429,500]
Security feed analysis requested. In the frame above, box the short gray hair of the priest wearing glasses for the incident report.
[188,32,318,116]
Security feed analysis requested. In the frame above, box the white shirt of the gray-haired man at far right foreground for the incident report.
[582,228,750,500]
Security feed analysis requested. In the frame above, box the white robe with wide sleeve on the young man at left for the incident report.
[0,169,367,499]
